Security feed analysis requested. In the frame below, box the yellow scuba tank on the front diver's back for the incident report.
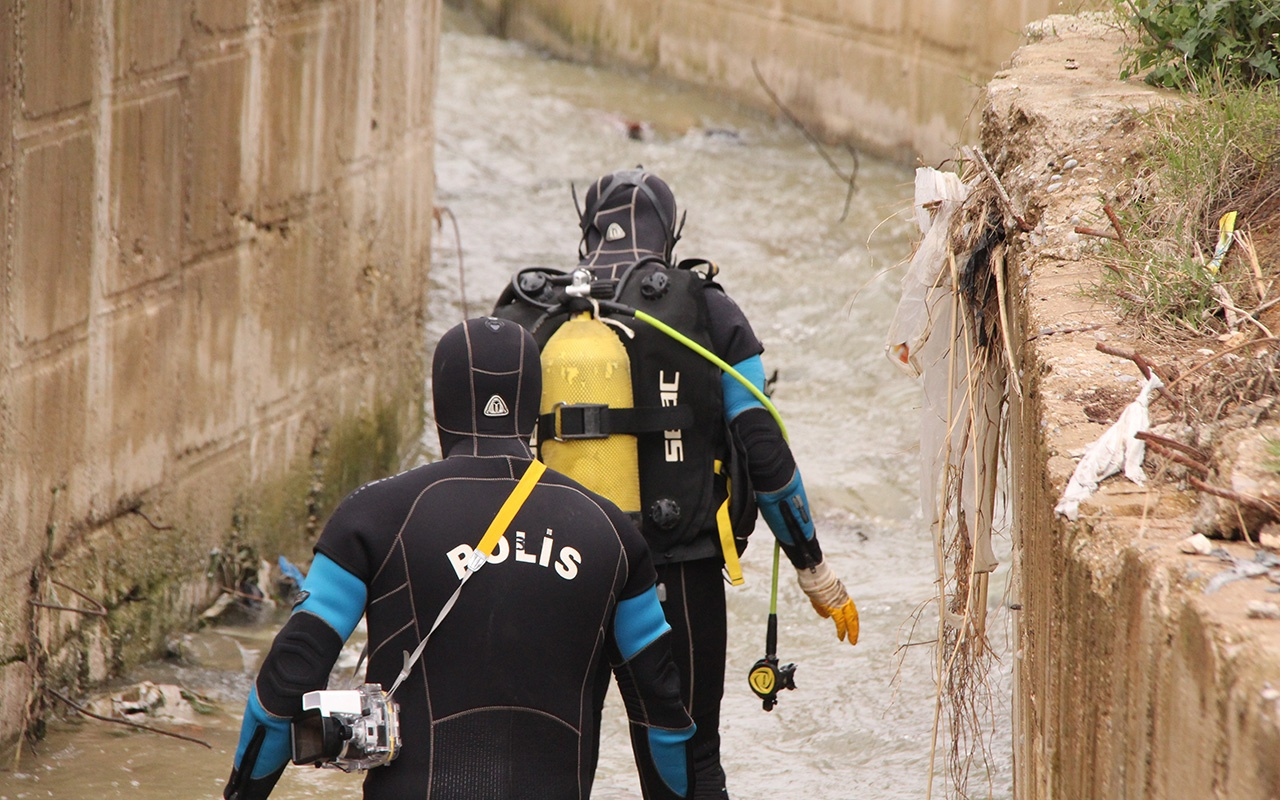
[540,312,640,513]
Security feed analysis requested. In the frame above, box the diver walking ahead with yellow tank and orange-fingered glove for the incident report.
[494,169,858,799]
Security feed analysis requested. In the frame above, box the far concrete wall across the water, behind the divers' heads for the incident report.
[451,0,1091,164]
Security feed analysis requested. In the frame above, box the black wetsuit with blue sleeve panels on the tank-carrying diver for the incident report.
[494,170,822,800]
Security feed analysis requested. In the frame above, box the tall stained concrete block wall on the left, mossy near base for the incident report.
[0,0,439,741]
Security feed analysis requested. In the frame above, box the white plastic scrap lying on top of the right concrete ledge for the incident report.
[1053,372,1165,522]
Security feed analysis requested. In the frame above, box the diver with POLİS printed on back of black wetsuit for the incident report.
[224,317,694,800]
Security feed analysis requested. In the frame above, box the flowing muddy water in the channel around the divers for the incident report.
[0,10,1011,800]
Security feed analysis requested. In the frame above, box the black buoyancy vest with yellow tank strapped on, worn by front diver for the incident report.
[495,256,781,585]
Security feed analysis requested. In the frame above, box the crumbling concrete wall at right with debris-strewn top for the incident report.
[982,18,1280,800]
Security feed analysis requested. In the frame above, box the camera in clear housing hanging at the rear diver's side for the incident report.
[289,684,399,772]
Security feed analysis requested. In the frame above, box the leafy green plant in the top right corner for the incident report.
[1116,0,1280,90]
